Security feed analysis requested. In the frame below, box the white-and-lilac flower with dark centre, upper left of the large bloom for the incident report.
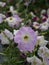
[5,15,22,27]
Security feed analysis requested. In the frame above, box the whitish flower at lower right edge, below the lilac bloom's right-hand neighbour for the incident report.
[38,46,49,58]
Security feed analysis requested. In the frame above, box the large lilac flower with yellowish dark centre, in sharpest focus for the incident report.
[14,26,37,52]
